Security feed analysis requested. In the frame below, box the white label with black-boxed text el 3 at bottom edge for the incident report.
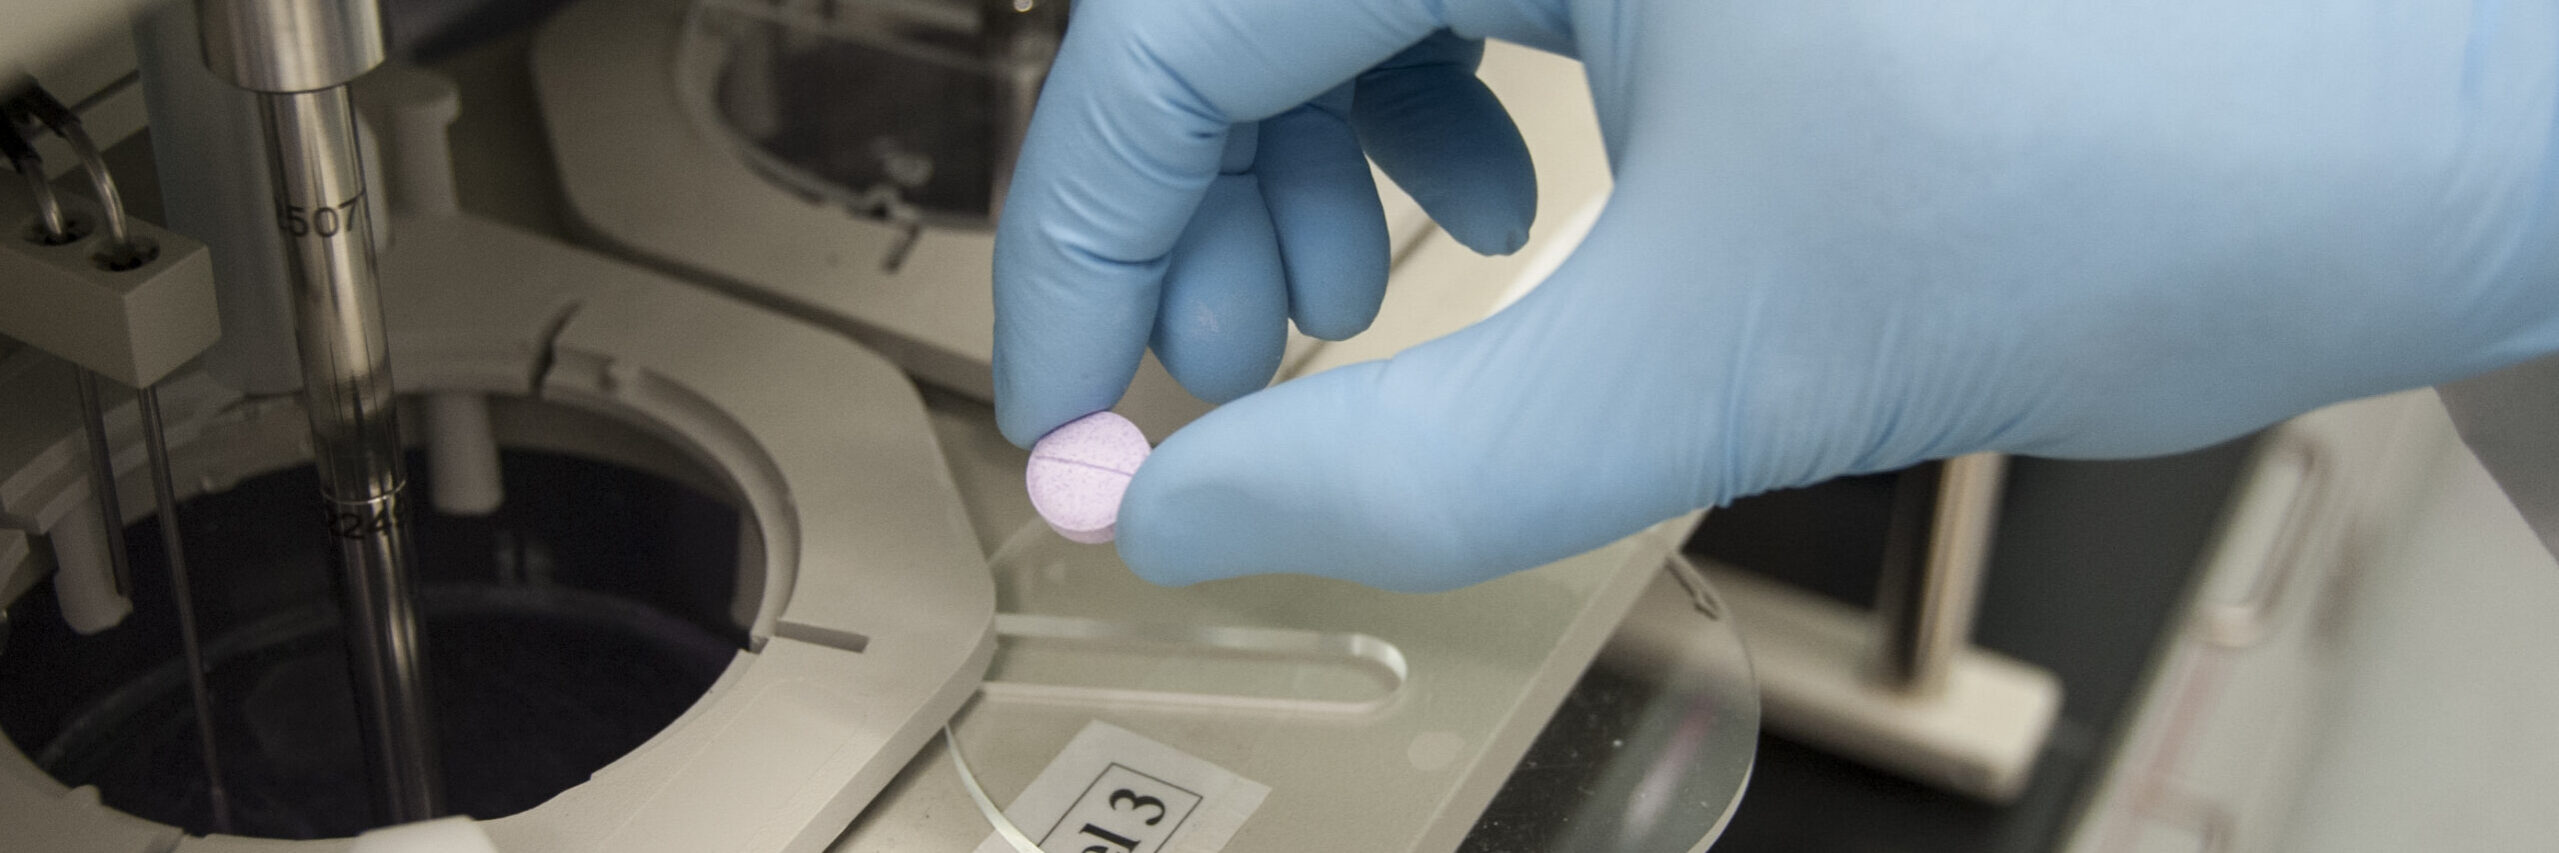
[978,720,1272,853]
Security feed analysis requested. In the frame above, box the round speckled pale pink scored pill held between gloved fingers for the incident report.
[1021,412,1154,546]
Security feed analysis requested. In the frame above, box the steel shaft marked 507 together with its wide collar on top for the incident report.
[197,0,443,822]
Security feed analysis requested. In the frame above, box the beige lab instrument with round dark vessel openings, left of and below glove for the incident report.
[0,0,1758,853]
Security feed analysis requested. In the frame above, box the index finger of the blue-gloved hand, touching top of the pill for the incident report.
[995,0,1441,446]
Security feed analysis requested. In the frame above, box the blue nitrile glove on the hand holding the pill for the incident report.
[995,0,2559,589]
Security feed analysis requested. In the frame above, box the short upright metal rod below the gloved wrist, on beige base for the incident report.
[1876,453,2009,697]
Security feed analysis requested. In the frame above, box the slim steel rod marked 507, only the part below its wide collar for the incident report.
[258,87,443,822]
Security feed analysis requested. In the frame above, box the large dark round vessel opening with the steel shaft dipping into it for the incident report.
[0,399,752,838]
